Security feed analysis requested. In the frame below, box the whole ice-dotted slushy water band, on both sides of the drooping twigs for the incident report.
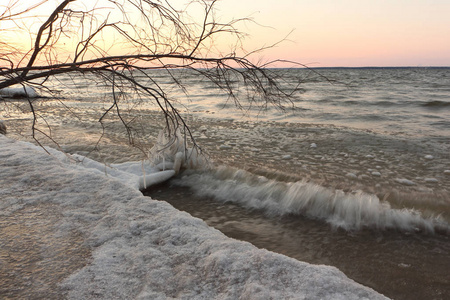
[3,113,450,222]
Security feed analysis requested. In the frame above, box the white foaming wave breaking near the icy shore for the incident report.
[173,167,450,234]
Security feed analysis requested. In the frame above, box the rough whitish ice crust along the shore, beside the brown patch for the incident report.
[0,136,386,299]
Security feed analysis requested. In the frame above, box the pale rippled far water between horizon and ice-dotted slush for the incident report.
[25,68,450,138]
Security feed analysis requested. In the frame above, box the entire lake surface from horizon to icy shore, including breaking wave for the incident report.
[0,68,450,299]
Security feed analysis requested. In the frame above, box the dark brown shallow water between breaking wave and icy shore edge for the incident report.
[145,183,450,299]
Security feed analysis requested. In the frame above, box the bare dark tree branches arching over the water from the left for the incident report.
[0,0,304,157]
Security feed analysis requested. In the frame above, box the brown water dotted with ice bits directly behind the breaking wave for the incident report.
[184,119,450,222]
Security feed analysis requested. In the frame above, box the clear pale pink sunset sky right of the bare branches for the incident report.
[218,0,450,67]
